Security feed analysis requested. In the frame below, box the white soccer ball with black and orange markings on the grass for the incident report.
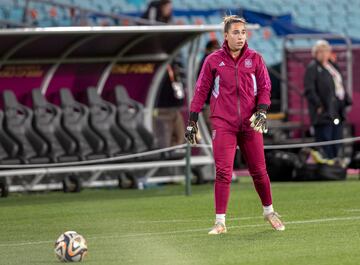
[55,231,87,262]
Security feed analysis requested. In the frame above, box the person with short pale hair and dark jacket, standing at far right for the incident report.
[304,40,351,159]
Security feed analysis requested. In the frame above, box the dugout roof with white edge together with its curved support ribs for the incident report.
[0,24,258,140]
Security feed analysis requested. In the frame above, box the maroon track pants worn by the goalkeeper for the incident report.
[213,128,272,214]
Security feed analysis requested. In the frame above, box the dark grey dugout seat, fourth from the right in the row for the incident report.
[32,89,79,162]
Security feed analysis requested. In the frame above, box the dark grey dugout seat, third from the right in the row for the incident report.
[60,88,106,160]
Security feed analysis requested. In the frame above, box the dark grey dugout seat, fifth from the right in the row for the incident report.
[3,90,50,163]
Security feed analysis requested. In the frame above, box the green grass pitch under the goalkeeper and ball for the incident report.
[0,177,360,265]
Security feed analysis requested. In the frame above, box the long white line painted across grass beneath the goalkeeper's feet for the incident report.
[0,216,360,247]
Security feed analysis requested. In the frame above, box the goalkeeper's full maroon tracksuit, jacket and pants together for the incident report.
[190,41,272,213]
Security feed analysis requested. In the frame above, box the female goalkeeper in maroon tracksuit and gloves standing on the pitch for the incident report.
[185,16,285,235]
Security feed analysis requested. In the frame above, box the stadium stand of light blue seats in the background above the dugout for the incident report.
[0,0,360,65]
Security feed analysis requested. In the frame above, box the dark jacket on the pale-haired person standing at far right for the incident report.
[304,60,351,125]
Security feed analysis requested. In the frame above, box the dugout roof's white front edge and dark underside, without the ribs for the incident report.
[0,25,228,60]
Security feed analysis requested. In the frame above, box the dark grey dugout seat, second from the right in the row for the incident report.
[87,88,131,156]
